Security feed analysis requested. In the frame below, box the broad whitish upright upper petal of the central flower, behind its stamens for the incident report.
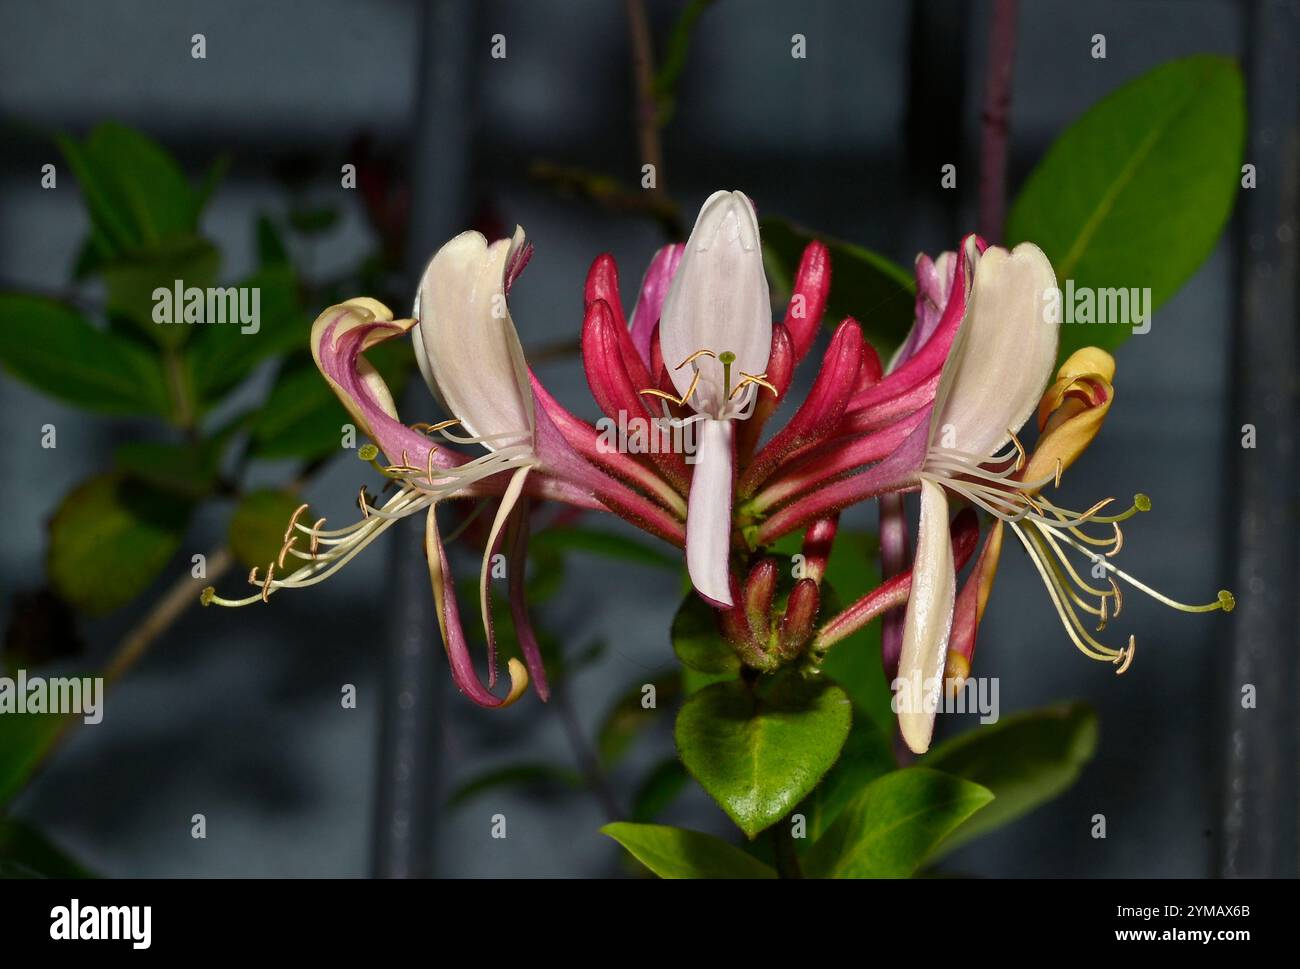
[659,191,772,415]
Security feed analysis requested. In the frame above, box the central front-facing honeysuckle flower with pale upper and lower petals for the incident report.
[646,191,772,606]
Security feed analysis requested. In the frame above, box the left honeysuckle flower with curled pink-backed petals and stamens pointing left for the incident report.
[204,230,684,706]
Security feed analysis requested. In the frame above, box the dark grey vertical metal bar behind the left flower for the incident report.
[373,0,478,878]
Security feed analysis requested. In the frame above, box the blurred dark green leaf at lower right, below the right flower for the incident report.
[920,702,1097,853]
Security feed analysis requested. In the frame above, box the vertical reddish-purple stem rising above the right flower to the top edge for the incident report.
[978,0,1019,242]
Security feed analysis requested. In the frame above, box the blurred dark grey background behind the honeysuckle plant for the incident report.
[0,0,1300,877]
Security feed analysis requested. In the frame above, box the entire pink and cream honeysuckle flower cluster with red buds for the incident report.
[204,191,1232,752]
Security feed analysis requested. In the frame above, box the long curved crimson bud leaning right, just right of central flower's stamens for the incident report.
[738,319,865,497]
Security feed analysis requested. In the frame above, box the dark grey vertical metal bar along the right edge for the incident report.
[1218,0,1300,878]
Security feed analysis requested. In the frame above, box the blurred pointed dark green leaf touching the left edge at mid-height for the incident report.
[0,294,169,415]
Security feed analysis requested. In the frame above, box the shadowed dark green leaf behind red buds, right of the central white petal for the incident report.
[759,219,917,358]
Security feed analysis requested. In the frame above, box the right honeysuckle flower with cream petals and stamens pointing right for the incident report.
[894,243,1232,753]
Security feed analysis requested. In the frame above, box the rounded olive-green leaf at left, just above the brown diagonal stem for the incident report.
[46,473,191,615]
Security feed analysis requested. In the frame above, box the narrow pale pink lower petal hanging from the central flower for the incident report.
[686,418,735,606]
